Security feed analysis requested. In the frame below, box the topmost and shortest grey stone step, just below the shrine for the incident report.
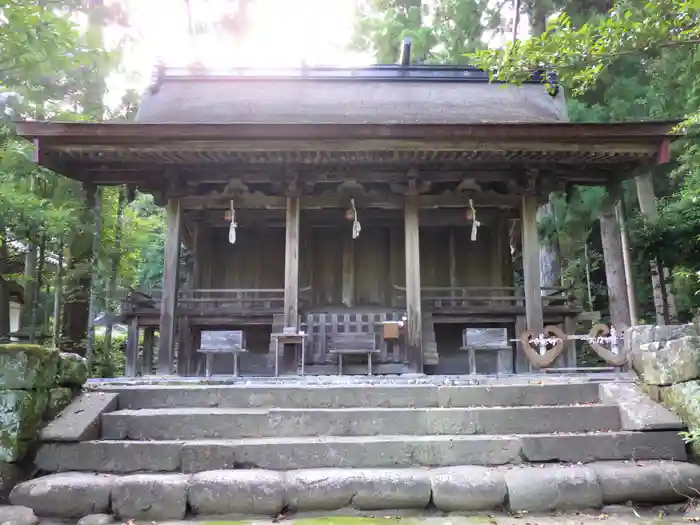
[106,383,599,410]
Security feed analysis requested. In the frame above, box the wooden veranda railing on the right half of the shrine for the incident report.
[394,285,576,310]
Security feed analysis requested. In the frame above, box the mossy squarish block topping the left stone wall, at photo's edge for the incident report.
[0,344,58,390]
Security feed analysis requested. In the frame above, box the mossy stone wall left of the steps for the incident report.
[0,344,87,502]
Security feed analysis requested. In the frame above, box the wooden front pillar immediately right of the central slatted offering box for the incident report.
[404,195,423,373]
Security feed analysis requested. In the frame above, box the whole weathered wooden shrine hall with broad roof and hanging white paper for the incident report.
[18,66,671,376]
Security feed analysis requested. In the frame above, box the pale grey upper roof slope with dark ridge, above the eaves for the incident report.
[137,66,567,124]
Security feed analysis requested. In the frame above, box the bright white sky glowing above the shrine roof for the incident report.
[126,0,370,78]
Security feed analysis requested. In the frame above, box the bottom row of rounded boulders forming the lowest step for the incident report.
[10,461,700,520]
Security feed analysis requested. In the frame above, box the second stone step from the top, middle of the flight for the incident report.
[102,405,620,440]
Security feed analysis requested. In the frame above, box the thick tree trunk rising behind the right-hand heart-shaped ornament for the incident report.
[600,186,630,330]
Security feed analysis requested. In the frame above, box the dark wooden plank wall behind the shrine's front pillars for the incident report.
[198,221,512,311]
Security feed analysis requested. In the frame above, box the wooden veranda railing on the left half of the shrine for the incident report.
[122,287,311,316]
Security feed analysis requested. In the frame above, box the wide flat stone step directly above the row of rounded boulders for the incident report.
[36,431,687,473]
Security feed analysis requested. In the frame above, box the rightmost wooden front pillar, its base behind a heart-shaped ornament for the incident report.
[521,195,544,335]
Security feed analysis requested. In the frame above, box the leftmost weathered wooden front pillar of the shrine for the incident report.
[156,198,182,375]
